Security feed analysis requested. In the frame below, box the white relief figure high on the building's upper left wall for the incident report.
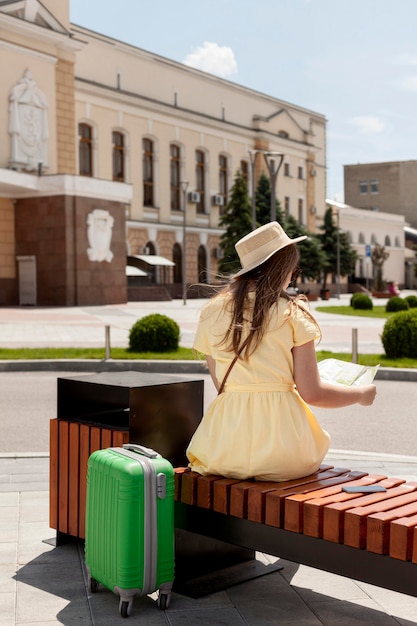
[9,69,48,172]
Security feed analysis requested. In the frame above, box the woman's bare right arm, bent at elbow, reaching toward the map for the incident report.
[292,341,376,409]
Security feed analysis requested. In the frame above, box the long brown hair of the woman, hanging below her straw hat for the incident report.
[222,245,315,359]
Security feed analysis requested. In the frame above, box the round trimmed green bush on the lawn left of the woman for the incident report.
[129,313,180,352]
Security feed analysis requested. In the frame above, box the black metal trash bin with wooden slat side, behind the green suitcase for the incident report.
[49,371,204,543]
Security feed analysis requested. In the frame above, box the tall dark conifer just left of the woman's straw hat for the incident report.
[219,170,252,274]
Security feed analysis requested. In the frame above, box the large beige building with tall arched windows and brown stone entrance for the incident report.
[0,0,326,306]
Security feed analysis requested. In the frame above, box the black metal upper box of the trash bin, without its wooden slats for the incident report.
[57,371,204,467]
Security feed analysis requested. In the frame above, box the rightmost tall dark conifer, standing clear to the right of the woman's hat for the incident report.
[318,208,358,289]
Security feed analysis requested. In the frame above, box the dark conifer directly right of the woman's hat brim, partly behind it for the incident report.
[284,215,327,280]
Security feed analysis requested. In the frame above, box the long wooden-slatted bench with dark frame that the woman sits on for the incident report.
[175,465,417,596]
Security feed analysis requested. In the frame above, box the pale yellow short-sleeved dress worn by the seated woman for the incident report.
[187,294,330,481]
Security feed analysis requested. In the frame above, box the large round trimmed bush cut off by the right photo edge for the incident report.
[381,310,417,359]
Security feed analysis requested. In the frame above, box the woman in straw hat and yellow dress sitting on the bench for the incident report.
[187,222,376,481]
